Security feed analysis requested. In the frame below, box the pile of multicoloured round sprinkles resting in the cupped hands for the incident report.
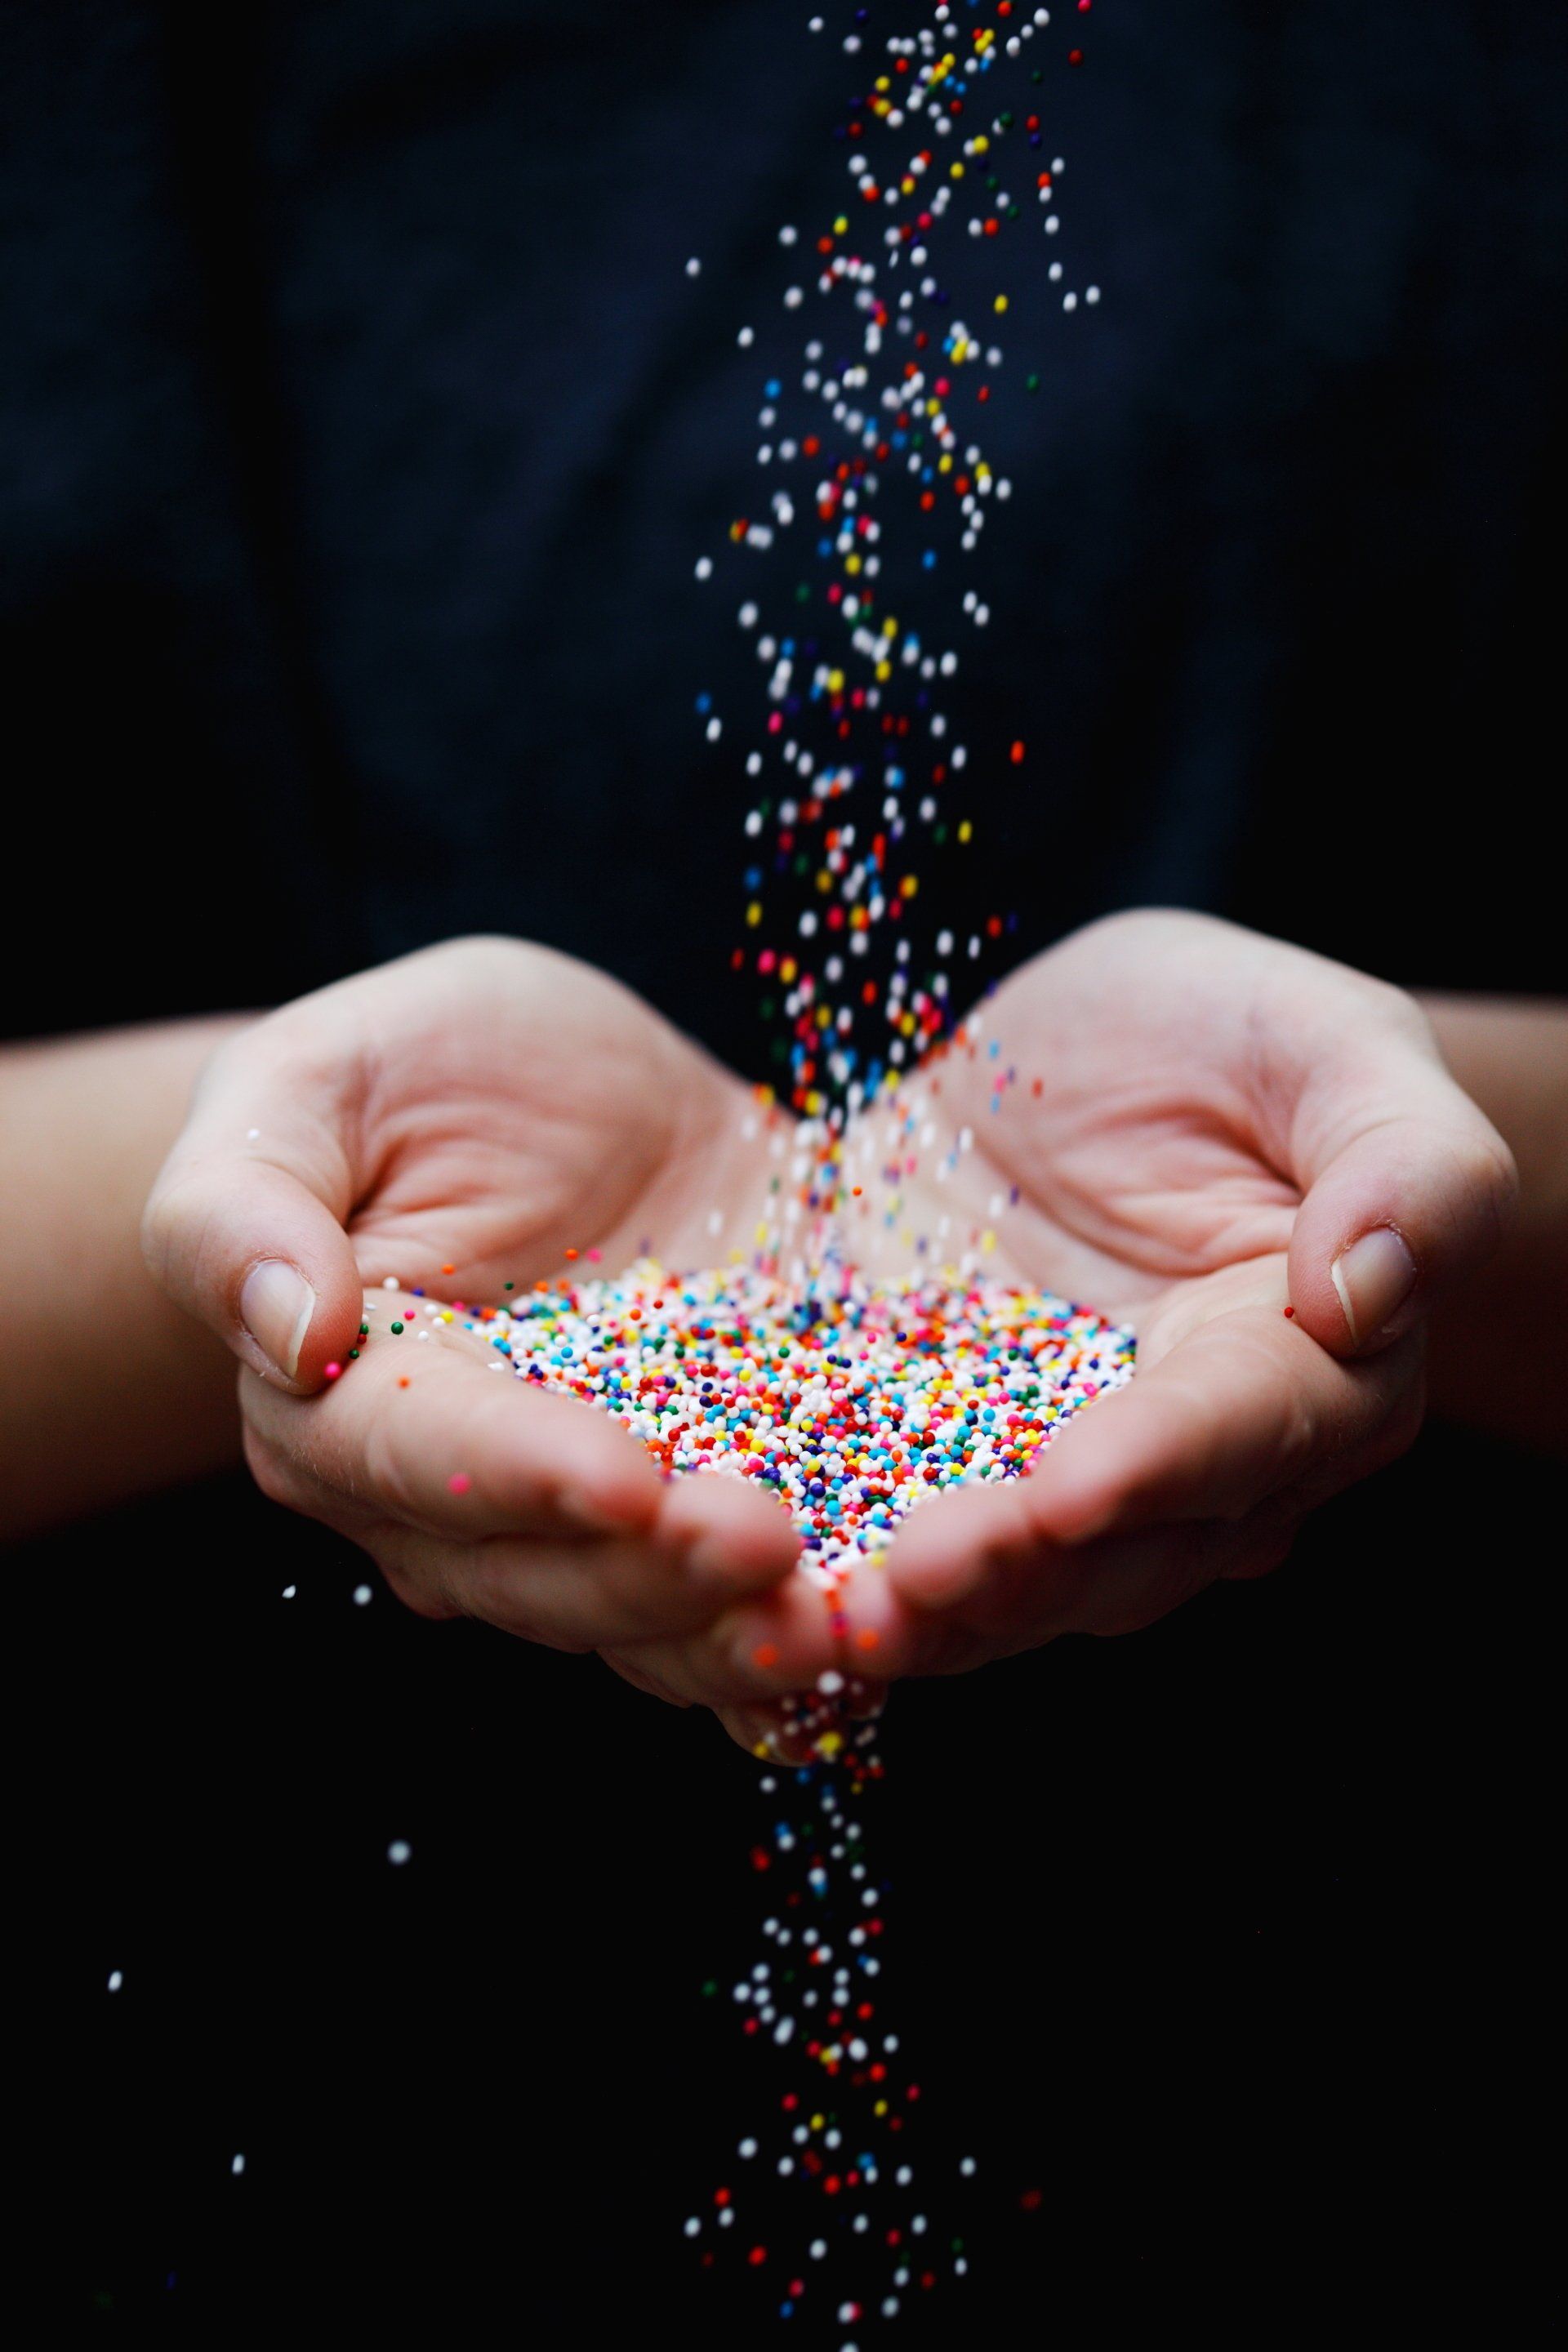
[491,1258,1133,1599]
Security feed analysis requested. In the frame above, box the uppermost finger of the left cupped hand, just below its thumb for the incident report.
[242,1336,662,1543]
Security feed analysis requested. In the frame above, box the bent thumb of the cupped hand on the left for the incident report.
[141,1013,364,1395]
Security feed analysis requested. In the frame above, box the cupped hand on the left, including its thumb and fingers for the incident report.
[144,938,832,1703]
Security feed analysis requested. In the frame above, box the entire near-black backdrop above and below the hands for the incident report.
[0,0,1568,2345]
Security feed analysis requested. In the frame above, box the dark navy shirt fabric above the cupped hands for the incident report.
[0,0,1566,1044]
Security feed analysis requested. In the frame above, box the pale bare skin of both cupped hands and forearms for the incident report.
[0,915,1568,1745]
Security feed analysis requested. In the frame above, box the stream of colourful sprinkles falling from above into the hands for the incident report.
[687,0,1100,1117]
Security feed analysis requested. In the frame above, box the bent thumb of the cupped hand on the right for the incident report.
[1290,1011,1517,1355]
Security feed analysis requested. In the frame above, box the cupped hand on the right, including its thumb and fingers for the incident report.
[822,912,1514,1693]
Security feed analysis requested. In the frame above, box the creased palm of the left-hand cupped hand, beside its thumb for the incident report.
[314,941,766,1298]
